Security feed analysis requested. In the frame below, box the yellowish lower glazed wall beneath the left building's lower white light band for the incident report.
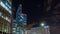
[0,20,11,34]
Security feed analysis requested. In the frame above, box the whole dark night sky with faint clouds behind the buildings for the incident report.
[13,0,60,34]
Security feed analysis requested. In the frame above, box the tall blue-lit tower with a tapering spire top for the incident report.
[12,5,27,34]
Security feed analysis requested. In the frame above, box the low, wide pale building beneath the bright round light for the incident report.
[27,26,50,34]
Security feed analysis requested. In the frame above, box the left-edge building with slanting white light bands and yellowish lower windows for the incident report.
[0,0,12,34]
